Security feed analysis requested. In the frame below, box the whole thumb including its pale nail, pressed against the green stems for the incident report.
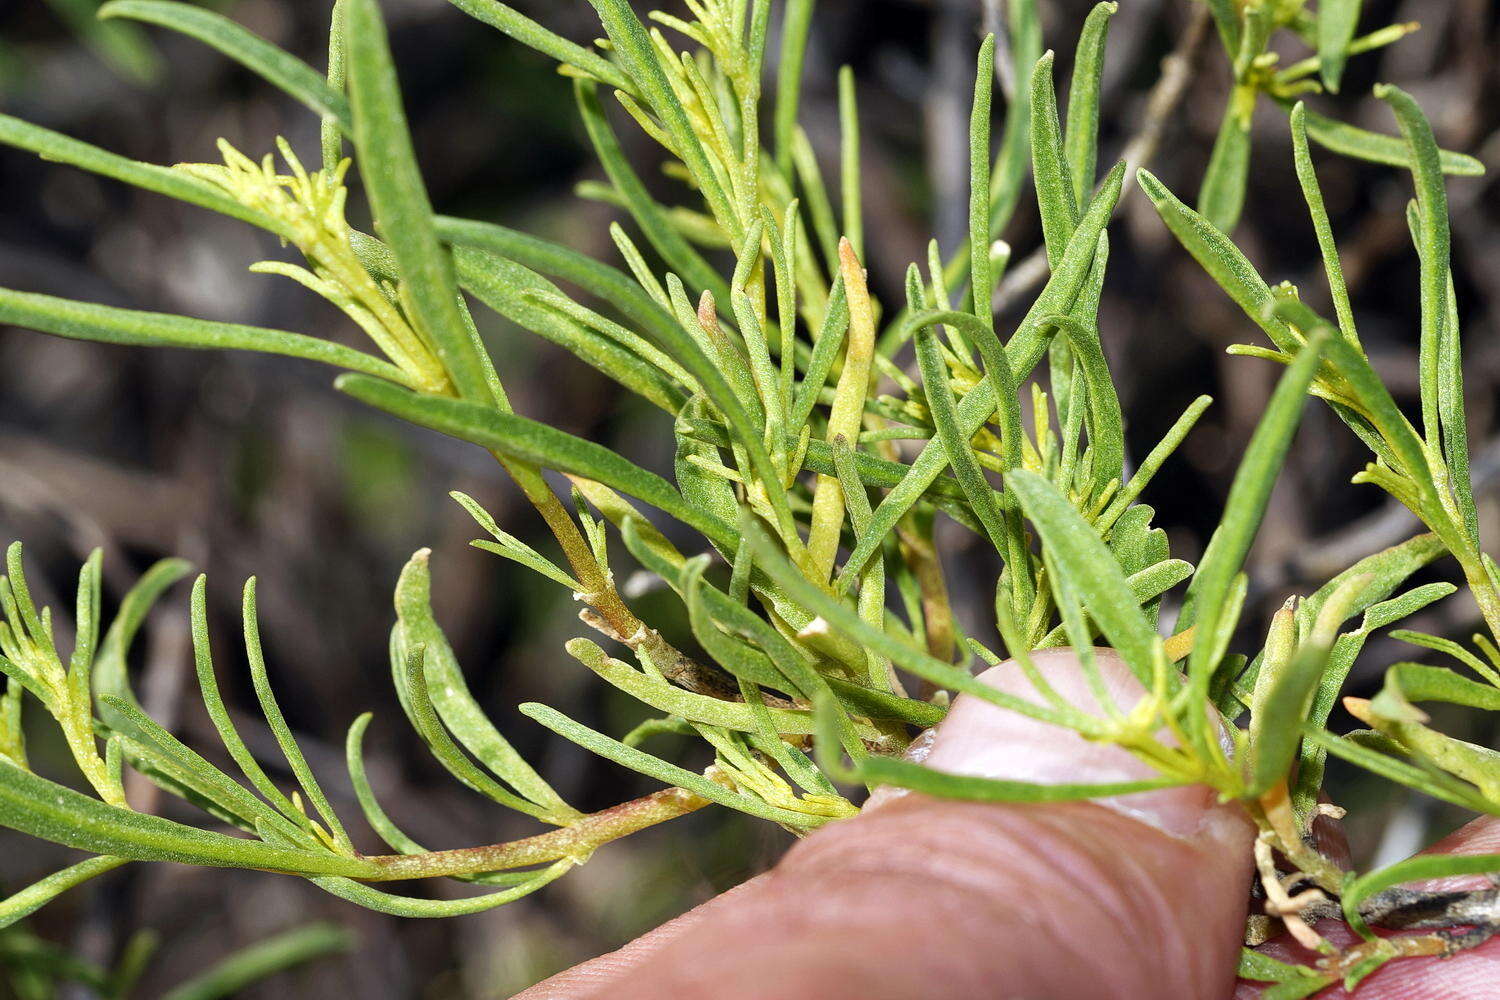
[522,651,1253,1000]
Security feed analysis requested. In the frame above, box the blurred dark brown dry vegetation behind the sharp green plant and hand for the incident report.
[0,0,1500,999]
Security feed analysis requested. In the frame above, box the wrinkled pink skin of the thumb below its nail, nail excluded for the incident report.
[590,795,1248,1000]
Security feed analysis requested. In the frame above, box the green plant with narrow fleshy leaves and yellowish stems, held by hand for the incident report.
[0,0,1500,996]
